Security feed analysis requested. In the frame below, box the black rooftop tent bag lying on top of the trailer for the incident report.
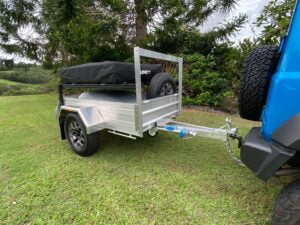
[60,61,162,84]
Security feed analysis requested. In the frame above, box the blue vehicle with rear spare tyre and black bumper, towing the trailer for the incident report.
[239,1,300,225]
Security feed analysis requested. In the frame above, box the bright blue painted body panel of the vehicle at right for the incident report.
[262,1,300,141]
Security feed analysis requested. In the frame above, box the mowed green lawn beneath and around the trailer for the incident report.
[0,95,291,225]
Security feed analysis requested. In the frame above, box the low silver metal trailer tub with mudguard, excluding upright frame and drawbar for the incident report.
[57,91,180,137]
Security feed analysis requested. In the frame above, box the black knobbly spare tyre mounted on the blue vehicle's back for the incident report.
[238,45,279,121]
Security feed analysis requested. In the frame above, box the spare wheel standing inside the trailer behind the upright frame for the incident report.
[147,73,176,99]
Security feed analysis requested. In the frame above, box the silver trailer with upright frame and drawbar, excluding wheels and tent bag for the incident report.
[56,47,241,146]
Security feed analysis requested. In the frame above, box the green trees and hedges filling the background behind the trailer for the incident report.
[0,0,295,110]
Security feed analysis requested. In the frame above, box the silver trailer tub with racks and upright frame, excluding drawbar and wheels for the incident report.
[56,47,183,138]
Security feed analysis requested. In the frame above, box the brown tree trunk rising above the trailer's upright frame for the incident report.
[134,0,148,45]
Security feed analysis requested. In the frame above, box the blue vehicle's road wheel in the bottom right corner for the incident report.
[272,180,300,225]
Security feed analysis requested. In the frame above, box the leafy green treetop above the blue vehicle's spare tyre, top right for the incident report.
[257,0,296,44]
